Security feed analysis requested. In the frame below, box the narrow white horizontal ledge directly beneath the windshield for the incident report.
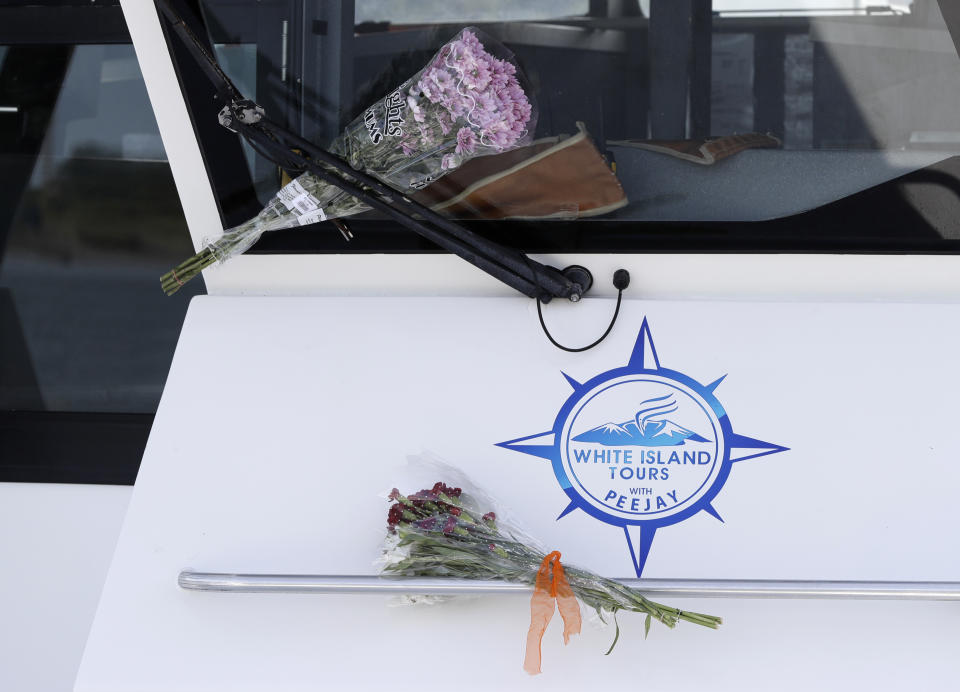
[204,254,960,302]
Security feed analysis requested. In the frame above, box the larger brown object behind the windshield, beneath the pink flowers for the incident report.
[414,123,627,219]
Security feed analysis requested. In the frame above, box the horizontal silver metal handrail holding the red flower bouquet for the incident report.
[178,571,960,601]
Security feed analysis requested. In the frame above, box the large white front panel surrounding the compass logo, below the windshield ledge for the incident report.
[76,297,960,692]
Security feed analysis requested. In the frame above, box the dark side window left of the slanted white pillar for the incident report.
[0,45,203,412]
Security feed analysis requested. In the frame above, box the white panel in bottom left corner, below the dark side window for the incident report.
[0,483,133,692]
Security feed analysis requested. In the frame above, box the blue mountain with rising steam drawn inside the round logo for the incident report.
[573,394,707,447]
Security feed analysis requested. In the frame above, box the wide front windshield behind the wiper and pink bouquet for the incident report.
[168,0,960,253]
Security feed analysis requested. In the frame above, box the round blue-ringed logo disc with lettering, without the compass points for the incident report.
[554,371,729,525]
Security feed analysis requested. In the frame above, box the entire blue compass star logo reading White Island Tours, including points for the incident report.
[497,319,787,577]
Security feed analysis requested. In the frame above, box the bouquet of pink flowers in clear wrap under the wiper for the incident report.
[161,28,536,295]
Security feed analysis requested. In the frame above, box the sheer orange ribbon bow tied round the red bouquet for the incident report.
[523,550,581,675]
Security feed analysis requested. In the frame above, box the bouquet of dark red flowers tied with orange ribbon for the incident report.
[383,482,721,674]
